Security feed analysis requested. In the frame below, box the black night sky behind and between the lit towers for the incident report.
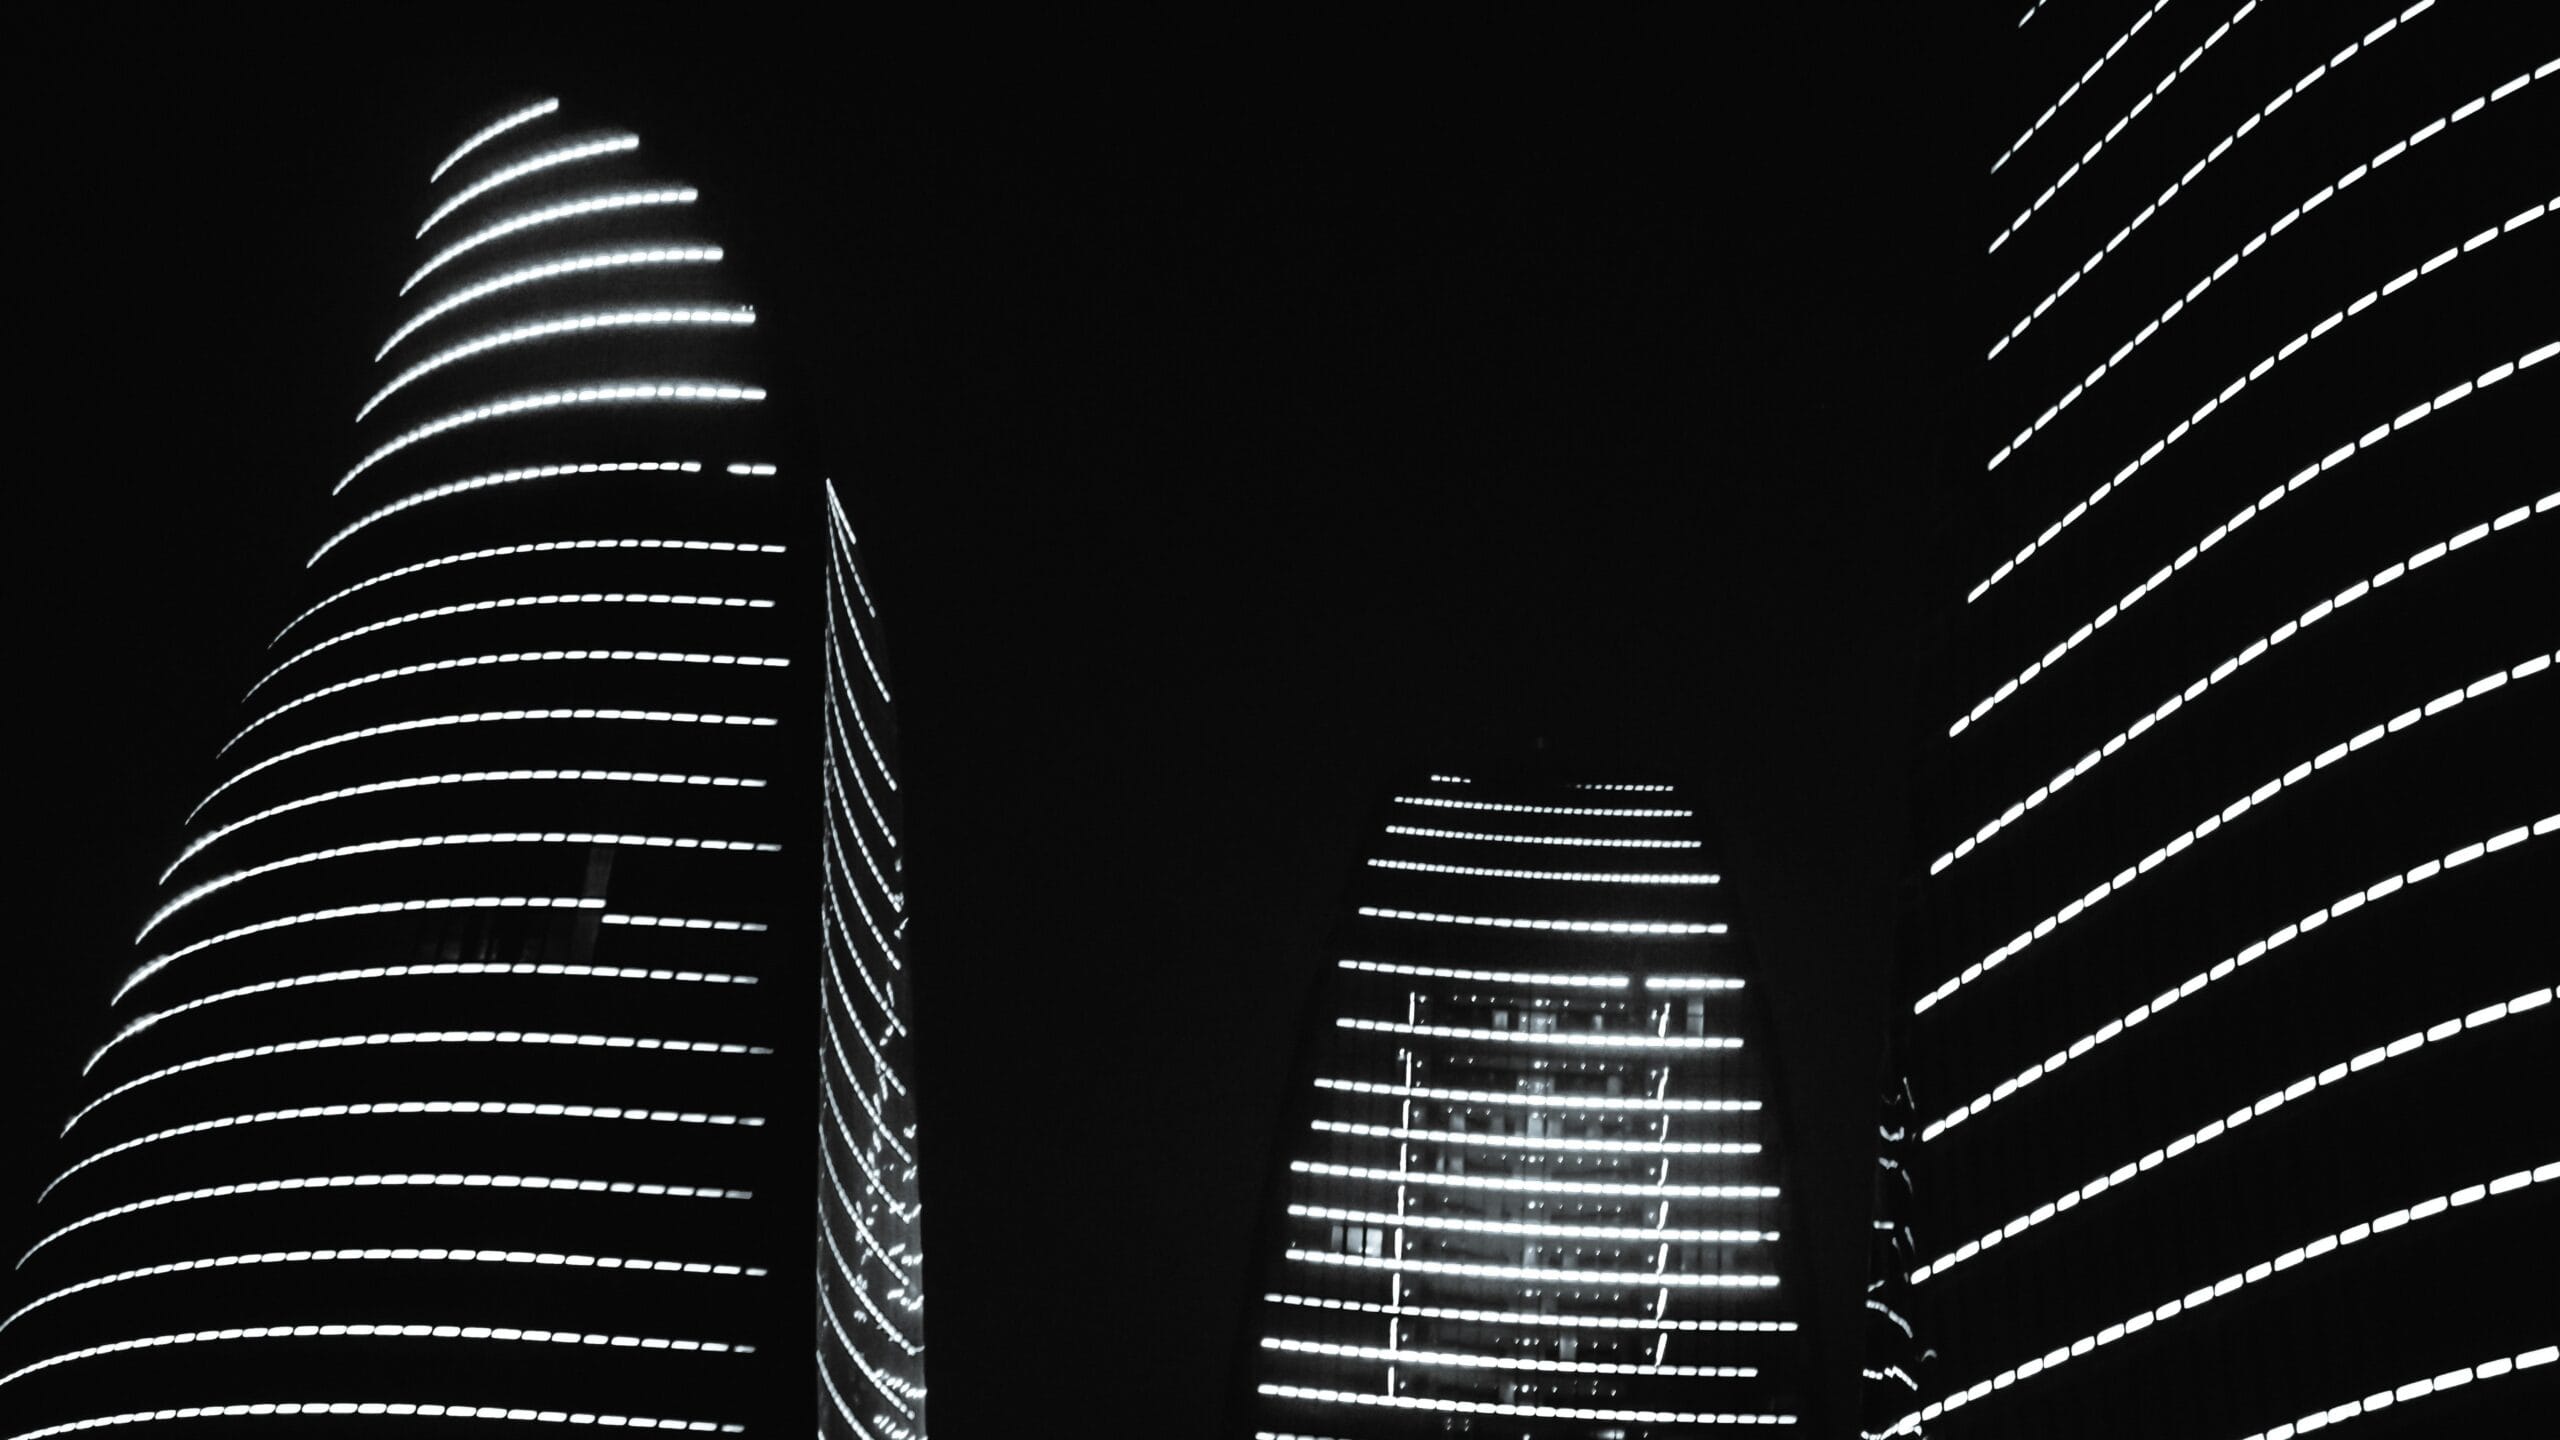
[15,19,1981,1440]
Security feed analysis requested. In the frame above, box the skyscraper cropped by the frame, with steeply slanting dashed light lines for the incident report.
[1866,0,2560,1440]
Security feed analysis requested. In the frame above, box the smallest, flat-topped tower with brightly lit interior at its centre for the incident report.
[1231,774,1802,1440]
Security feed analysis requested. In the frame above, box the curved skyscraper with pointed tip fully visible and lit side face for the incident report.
[0,100,924,1440]
